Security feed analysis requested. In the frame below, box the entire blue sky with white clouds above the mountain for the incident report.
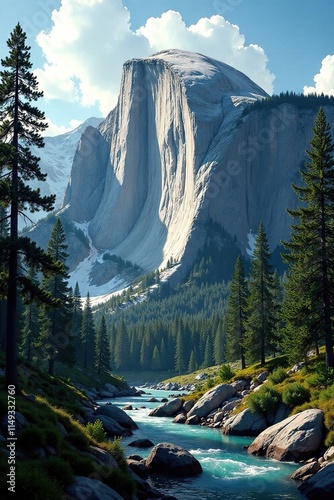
[0,0,334,135]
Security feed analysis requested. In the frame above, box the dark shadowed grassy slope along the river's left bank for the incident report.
[0,356,134,500]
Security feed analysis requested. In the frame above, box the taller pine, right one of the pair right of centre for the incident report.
[244,222,276,364]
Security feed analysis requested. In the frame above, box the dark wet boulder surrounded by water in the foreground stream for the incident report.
[146,443,202,476]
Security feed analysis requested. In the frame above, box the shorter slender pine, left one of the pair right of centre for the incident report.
[225,256,248,369]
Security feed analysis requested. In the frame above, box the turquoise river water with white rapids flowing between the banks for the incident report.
[97,390,303,500]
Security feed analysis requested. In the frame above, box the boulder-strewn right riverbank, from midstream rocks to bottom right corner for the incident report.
[143,372,334,499]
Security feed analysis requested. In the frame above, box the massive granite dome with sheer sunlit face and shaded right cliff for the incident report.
[52,50,334,293]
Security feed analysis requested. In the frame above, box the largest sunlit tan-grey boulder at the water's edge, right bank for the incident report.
[248,410,324,462]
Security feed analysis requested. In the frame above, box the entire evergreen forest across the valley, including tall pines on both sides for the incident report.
[0,25,334,393]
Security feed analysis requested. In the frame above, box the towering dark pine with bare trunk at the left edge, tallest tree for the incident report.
[0,24,59,394]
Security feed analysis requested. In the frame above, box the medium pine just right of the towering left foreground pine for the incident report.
[40,217,75,375]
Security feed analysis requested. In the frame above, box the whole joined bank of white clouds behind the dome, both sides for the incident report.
[36,0,275,115]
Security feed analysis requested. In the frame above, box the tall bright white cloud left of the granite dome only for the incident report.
[35,0,149,115]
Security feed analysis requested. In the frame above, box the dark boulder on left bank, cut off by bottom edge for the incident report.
[66,476,123,500]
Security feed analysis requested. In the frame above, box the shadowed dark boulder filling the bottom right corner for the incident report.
[298,463,334,500]
